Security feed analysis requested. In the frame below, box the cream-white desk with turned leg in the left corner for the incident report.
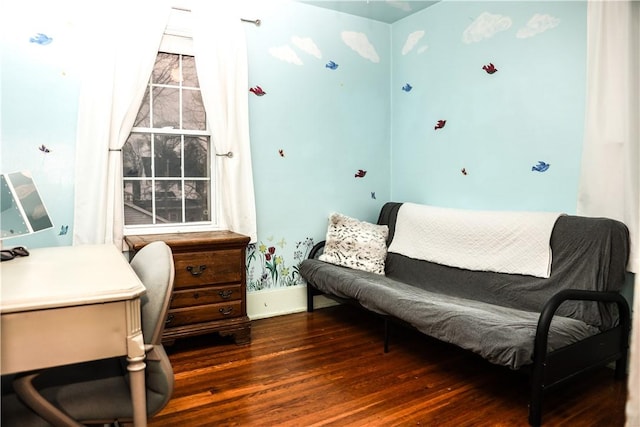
[0,244,147,426]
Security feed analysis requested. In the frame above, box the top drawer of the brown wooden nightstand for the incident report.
[173,248,244,289]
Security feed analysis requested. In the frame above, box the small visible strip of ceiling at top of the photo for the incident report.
[298,0,438,24]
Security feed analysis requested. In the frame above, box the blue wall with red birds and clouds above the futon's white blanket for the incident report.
[391,1,586,213]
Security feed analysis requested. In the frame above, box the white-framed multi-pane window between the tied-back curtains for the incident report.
[122,52,216,232]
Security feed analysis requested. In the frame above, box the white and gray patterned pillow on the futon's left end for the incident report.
[319,213,389,274]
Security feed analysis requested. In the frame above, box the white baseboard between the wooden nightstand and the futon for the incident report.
[247,286,337,320]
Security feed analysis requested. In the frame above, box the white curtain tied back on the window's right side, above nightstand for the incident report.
[192,1,257,242]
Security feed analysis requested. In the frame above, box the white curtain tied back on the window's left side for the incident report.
[73,0,170,247]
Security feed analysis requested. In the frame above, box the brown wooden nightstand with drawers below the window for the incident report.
[125,231,251,344]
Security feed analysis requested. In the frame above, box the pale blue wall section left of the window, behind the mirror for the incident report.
[0,2,80,247]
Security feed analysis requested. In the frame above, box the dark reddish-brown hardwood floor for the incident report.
[149,306,626,427]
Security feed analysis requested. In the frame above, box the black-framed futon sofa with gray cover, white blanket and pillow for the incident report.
[299,202,630,425]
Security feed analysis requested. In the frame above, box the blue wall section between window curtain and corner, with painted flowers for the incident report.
[246,3,391,290]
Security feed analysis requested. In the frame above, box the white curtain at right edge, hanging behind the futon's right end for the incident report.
[577,1,640,273]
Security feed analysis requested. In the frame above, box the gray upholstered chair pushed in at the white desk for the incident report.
[2,242,174,426]
